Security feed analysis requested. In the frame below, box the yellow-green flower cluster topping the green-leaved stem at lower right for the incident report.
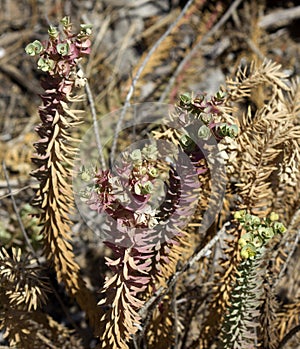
[234,210,286,259]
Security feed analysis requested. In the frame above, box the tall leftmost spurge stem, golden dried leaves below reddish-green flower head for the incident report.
[25,17,95,323]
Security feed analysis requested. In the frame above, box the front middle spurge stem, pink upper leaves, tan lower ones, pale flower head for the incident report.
[85,144,176,348]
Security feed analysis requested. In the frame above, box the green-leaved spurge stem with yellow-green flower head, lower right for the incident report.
[220,210,286,349]
